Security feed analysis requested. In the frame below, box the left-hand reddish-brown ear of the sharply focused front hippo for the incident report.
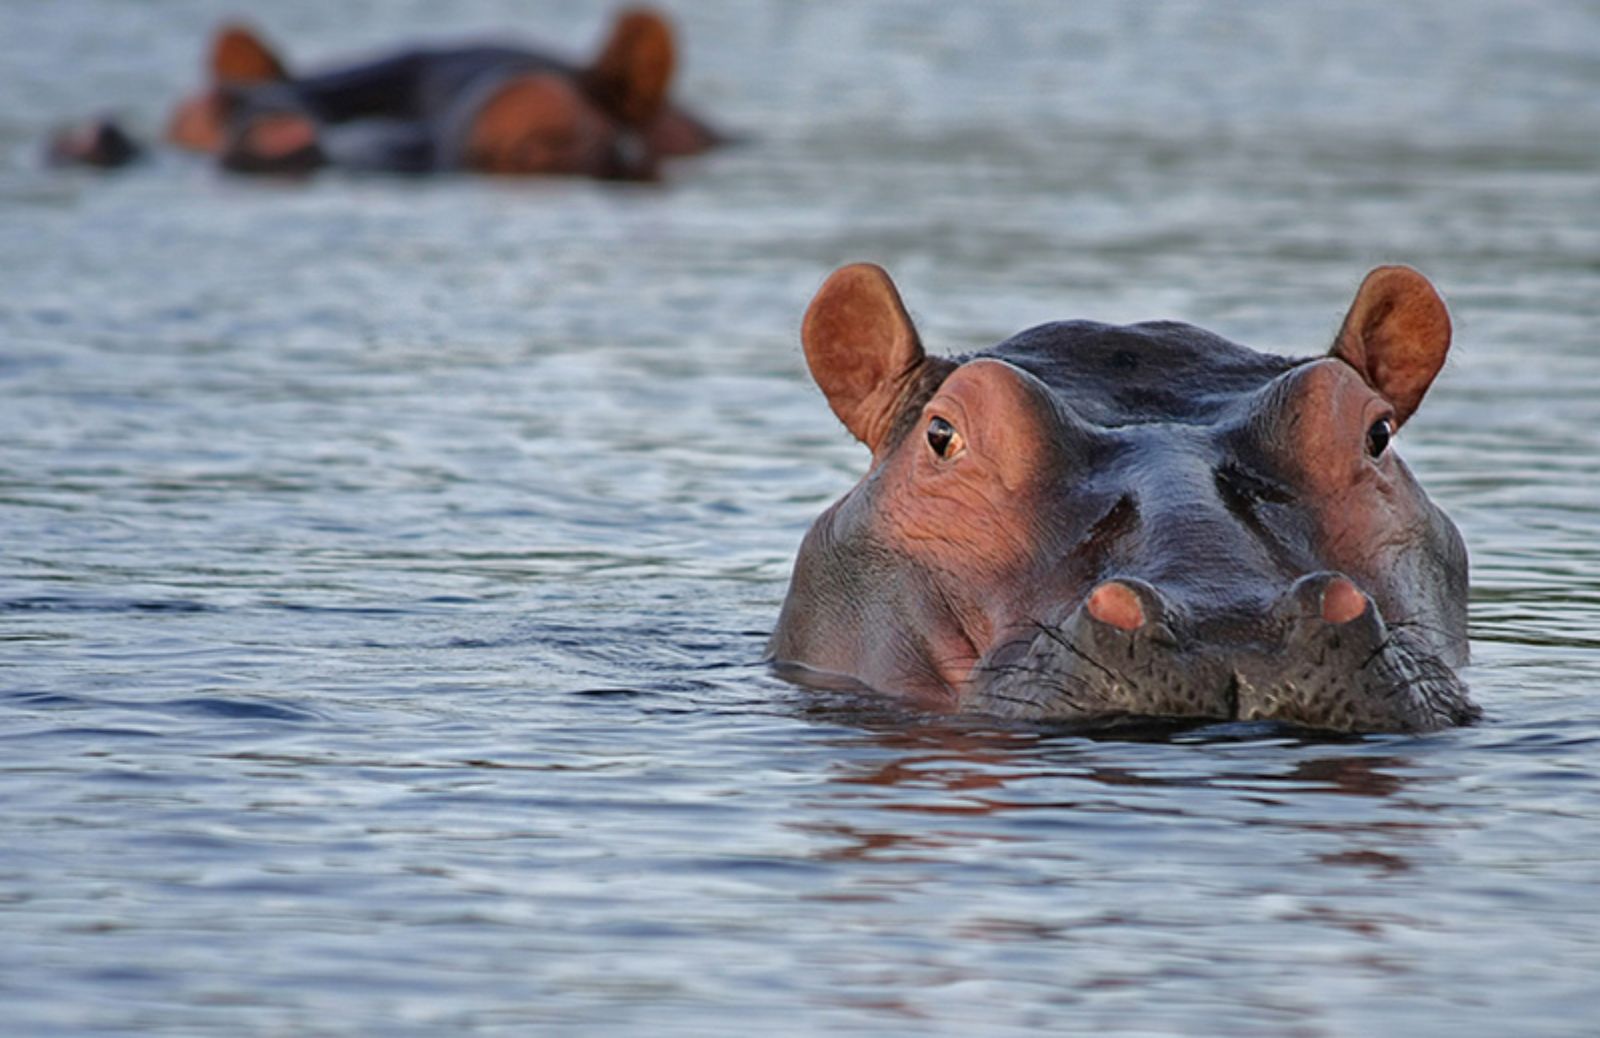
[800,264,928,453]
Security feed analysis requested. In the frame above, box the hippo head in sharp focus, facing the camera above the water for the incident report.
[768,264,1478,733]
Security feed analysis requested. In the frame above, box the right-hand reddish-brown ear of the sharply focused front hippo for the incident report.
[1331,267,1450,429]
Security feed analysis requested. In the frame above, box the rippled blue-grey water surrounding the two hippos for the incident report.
[0,0,1600,1036]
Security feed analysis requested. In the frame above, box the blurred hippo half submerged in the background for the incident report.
[51,8,723,179]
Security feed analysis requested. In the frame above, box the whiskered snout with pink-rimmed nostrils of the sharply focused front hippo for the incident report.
[968,573,1477,731]
